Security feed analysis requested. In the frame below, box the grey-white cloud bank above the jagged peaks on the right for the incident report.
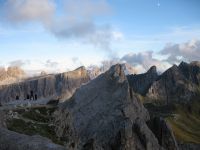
[121,39,200,72]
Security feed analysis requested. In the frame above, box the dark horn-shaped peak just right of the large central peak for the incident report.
[127,66,158,95]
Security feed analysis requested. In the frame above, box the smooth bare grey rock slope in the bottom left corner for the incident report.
[0,128,65,150]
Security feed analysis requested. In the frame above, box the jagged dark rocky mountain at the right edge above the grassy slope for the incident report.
[147,62,200,103]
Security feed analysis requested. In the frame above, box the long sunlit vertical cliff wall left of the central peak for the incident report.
[0,67,90,103]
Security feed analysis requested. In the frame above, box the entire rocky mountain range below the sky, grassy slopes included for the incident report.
[0,61,200,150]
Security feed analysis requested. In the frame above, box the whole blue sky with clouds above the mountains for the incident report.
[0,0,200,72]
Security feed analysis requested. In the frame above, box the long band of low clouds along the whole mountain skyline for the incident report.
[3,40,200,73]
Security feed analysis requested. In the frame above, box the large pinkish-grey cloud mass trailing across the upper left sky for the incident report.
[0,0,114,50]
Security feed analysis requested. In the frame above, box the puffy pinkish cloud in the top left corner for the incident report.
[3,0,55,23]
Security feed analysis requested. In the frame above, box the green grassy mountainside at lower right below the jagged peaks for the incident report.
[144,96,200,144]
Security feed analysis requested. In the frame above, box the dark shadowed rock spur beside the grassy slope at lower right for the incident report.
[148,117,179,150]
